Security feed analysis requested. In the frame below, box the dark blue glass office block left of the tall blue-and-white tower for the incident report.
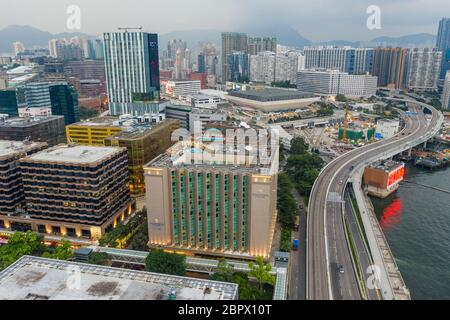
[49,82,80,125]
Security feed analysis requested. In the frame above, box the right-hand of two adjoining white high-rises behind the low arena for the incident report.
[275,51,305,84]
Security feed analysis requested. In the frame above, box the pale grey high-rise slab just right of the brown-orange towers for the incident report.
[406,48,442,91]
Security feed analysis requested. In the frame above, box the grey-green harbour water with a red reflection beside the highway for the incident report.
[372,165,450,299]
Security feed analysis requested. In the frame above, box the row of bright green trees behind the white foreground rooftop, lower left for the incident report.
[0,231,73,270]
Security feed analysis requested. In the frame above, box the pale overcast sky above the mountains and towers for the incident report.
[0,0,450,41]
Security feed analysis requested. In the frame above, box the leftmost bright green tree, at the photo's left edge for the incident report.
[0,231,43,269]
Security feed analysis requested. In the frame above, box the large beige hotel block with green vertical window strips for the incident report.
[144,140,278,259]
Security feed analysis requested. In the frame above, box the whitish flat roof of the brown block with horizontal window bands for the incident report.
[29,145,118,163]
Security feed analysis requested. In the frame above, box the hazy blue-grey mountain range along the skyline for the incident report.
[0,24,436,53]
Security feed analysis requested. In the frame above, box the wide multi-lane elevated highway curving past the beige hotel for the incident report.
[306,99,438,300]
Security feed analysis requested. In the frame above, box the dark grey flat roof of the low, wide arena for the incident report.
[228,88,315,102]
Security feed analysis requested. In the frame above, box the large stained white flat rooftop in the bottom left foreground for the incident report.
[0,256,238,300]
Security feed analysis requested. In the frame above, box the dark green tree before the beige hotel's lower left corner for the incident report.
[145,250,186,276]
